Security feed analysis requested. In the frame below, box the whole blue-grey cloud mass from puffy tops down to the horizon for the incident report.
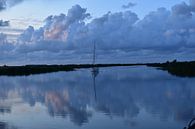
[1,0,195,63]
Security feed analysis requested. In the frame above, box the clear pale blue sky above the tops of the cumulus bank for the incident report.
[0,0,189,29]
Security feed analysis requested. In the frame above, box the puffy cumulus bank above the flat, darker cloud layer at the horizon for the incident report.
[19,3,195,50]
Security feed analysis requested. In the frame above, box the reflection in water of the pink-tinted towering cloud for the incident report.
[45,91,91,126]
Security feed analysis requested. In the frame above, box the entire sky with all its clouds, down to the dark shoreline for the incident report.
[0,0,195,65]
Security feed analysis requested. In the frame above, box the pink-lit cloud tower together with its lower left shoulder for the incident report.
[18,5,90,42]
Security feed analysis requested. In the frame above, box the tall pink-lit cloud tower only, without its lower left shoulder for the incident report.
[44,5,90,40]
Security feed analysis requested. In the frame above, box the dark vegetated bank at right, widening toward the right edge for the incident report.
[147,60,195,77]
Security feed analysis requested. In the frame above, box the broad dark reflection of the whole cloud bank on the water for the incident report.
[0,67,195,126]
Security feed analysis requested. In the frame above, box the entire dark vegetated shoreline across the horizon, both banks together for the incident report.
[0,60,195,77]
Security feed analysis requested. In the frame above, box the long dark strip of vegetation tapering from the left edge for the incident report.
[0,64,142,76]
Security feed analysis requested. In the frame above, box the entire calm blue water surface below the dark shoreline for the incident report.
[0,67,195,129]
